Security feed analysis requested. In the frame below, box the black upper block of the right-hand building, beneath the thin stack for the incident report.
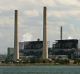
[53,39,78,49]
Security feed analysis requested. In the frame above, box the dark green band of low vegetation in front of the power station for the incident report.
[1,57,80,65]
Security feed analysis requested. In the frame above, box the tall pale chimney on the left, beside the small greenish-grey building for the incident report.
[14,10,19,61]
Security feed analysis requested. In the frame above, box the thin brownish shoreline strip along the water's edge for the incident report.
[0,63,80,67]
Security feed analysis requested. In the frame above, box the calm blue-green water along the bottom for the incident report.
[0,66,80,74]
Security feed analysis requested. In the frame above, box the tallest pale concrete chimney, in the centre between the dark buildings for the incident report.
[43,7,48,59]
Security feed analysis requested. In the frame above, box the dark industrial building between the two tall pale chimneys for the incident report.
[19,40,43,58]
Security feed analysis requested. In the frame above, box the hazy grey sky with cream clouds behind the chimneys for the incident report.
[0,0,80,54]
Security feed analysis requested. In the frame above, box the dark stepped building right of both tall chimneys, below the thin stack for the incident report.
[52,39,79,58]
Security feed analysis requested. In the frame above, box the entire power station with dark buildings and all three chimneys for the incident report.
[5,7,80,62]
